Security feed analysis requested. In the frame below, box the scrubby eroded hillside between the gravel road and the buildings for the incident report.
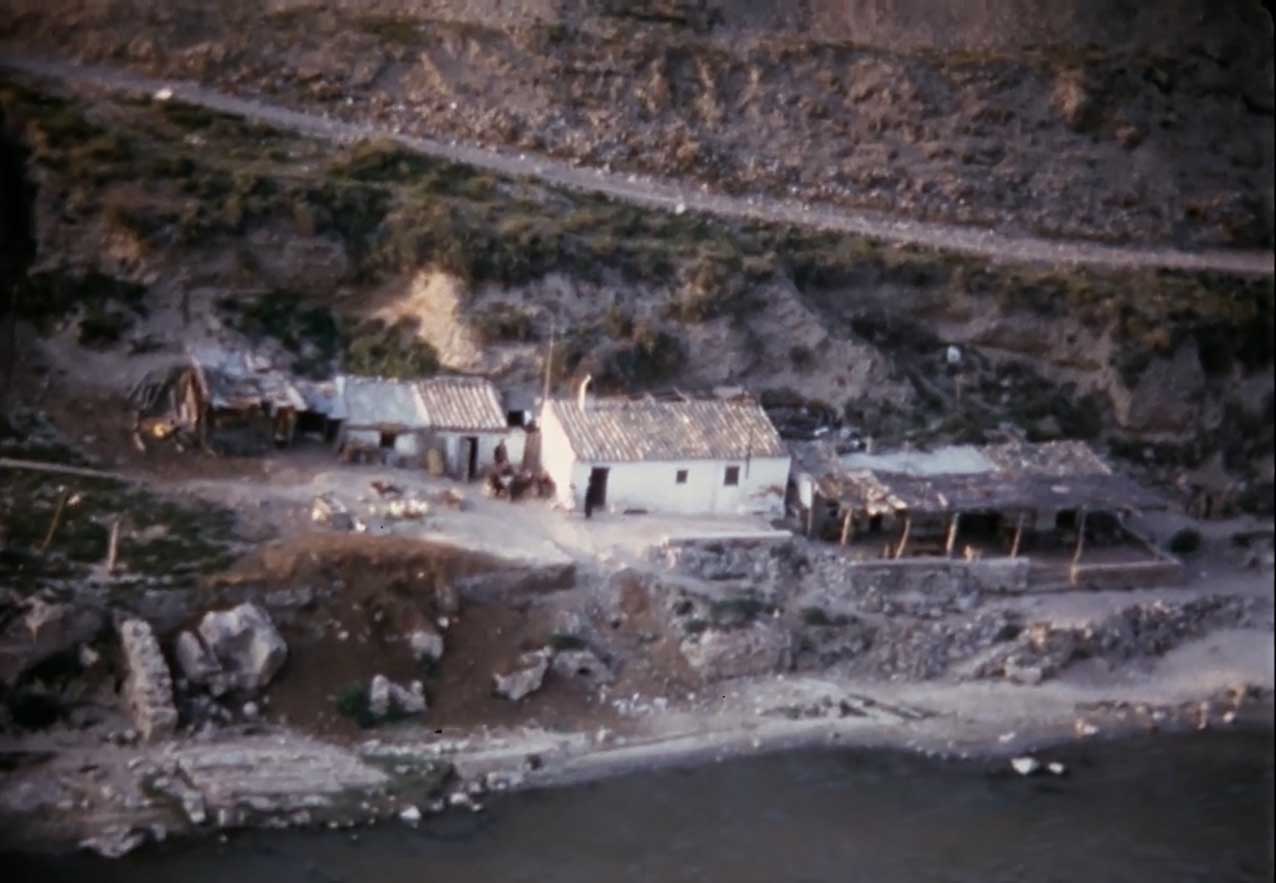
[0,83,1273,510]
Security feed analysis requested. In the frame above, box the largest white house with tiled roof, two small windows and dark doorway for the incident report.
[541,388,790,517]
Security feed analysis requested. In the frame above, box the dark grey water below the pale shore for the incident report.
[9,731,1273,883]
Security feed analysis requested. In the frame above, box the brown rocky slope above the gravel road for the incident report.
[0,0,1276,246]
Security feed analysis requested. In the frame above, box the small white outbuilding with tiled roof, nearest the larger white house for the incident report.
[417,376,526,480]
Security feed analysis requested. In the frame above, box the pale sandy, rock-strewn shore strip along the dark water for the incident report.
[0,651,1273,855]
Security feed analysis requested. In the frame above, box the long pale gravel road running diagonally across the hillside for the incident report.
[0,47,1273,276]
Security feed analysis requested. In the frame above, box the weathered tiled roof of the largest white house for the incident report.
[549,399,789,463]
